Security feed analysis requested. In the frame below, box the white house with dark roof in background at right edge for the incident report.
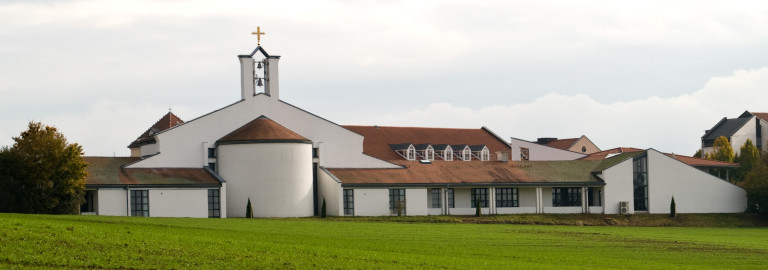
[701,111,768,154]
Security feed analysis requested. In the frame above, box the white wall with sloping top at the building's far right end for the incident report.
[644,150,754,213]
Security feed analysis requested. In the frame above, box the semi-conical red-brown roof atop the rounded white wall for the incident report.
[217,115,310,144]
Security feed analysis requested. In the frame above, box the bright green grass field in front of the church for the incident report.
[0,214,768,269]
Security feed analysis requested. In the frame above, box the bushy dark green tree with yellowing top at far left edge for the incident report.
[0,122,87,214]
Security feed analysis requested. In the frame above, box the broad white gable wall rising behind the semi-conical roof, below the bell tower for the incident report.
[129,94,398,169]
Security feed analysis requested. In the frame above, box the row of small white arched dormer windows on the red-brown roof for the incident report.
[389,143,491,161]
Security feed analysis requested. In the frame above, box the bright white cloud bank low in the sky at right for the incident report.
[356,67,768,155]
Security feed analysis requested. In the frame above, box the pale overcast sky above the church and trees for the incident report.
[0,0,768,156]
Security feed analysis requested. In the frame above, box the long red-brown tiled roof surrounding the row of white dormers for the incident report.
[343,126,510,160]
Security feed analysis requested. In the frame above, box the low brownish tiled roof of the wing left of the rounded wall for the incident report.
[83,157,221,187]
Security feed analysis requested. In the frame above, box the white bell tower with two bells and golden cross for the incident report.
[237,27,280,99]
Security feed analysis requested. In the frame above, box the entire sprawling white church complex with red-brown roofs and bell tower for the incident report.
[81,42,746,218]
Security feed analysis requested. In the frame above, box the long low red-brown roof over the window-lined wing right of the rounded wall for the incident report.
[326,160,603,185]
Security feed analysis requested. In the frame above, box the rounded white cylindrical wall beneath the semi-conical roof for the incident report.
[217,143,314,217]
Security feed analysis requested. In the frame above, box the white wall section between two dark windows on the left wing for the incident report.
[149,188,208,218]
